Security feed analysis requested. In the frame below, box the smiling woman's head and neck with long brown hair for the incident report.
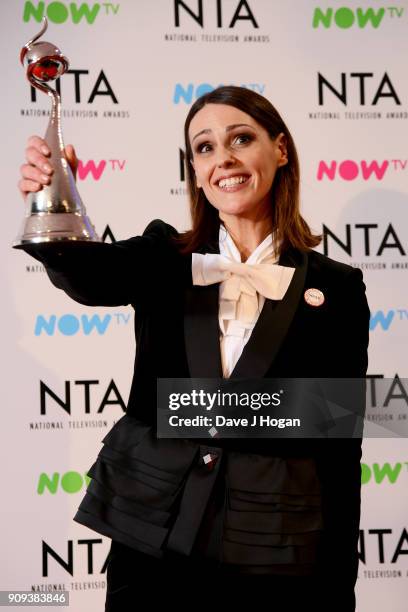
[175,87,320,261]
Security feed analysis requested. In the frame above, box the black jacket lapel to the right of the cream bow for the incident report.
[230,250,308,378]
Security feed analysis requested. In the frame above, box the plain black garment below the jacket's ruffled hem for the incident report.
[105,541,355,612]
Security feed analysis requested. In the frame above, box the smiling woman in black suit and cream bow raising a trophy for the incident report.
[19,87,369,612]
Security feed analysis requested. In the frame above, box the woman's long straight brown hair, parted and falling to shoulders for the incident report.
[176,86,321,254]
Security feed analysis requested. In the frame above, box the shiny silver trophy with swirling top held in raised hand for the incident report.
[13,17,101,250]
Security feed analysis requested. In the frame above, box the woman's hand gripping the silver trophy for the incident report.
[18,136,78,199]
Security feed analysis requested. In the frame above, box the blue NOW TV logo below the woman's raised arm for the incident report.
[34,312,130,336]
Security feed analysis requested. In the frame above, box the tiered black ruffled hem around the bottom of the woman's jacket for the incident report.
[74,415,323,575]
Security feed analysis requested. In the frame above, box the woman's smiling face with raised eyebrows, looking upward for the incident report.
[189,104,287,218]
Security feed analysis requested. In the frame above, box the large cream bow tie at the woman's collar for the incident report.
[192,253,295,323]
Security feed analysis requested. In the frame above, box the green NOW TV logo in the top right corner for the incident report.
[312,6,404,30]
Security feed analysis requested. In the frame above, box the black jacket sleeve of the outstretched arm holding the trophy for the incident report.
[22,219,185,306]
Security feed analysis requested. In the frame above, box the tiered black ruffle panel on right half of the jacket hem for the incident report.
[223,453,323,574]
